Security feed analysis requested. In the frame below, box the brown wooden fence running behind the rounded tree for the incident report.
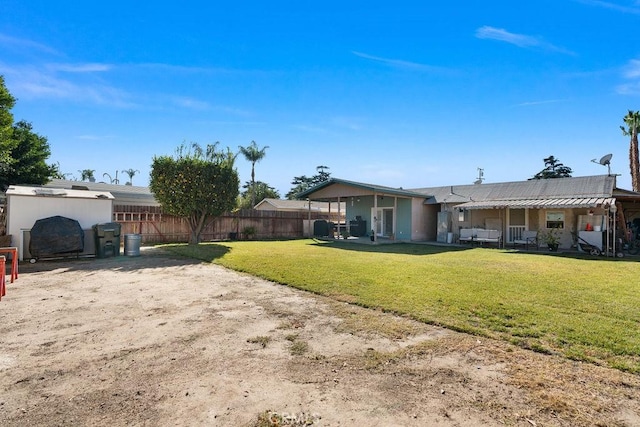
[113,205,344,243]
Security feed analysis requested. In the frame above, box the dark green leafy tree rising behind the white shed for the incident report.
[0,121,55,190]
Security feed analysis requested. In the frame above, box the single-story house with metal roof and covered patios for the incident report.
[299,175,640,248]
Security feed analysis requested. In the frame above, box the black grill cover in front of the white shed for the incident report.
[29,215,84,258]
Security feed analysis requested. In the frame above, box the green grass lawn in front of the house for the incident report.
[161,240,640,373]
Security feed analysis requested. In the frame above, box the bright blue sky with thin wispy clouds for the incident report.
[0,0,640,196]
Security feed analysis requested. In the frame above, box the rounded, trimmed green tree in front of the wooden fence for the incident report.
[149,142,240,244]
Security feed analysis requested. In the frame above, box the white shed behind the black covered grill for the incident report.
[7,185,113,261]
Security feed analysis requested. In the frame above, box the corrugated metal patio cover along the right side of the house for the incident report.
[456,197,616,209]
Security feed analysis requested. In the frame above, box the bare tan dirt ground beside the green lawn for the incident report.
[0,248,640,427]
